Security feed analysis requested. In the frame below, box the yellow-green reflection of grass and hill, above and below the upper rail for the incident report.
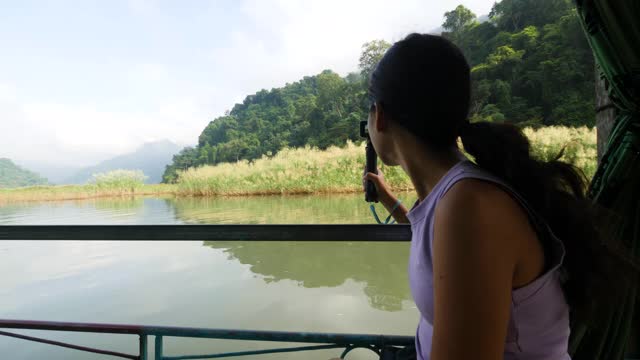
[168,194,413,311]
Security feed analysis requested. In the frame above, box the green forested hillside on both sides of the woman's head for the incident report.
[163,0,595,182]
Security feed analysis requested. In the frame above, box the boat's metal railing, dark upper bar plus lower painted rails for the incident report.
[0,224,414,360]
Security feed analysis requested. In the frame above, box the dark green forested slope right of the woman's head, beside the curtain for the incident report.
[443,0,595,126]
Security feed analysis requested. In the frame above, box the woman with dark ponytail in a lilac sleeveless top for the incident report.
[363,34,606,360]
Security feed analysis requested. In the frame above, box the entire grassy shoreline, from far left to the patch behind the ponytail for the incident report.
[0,127,596,204]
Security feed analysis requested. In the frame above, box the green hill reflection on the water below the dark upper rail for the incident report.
[204,241,411,311]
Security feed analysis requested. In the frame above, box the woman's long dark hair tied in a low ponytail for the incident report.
[369,34,622,315]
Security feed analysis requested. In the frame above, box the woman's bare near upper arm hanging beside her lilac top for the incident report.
[431,180,522,360]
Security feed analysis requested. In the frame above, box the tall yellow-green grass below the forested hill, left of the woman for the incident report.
[178,142,408,196]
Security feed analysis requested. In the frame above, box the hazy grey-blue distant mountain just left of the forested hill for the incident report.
[63,140,182,184]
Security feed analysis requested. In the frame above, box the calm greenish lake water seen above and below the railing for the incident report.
[0,194,418,359]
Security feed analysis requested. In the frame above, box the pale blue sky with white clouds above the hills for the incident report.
[0,0,494,167]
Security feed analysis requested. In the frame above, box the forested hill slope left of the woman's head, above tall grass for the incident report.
[164,70,367,182]
